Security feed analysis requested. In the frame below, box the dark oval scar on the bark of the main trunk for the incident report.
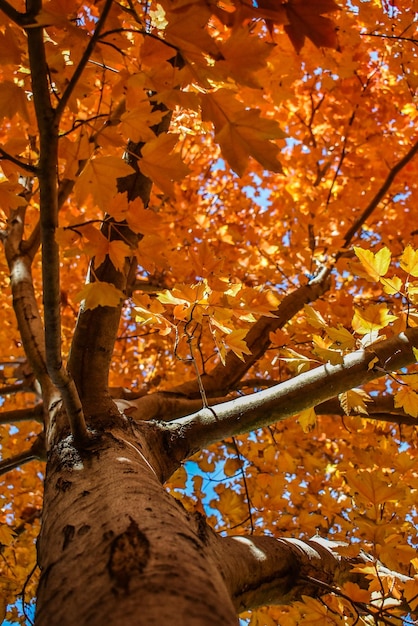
[107,517,150,594]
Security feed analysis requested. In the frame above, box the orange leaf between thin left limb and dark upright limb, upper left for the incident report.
[74,156,134,211]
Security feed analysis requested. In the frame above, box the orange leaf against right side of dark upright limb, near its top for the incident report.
[139,133,189,195]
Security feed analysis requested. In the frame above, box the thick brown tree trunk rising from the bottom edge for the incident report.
[35,426,237,626]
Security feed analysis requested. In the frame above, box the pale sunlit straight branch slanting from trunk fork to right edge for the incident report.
[171,328,418,458]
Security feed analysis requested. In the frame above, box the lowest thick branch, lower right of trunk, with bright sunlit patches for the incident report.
[213,536,408,612]
